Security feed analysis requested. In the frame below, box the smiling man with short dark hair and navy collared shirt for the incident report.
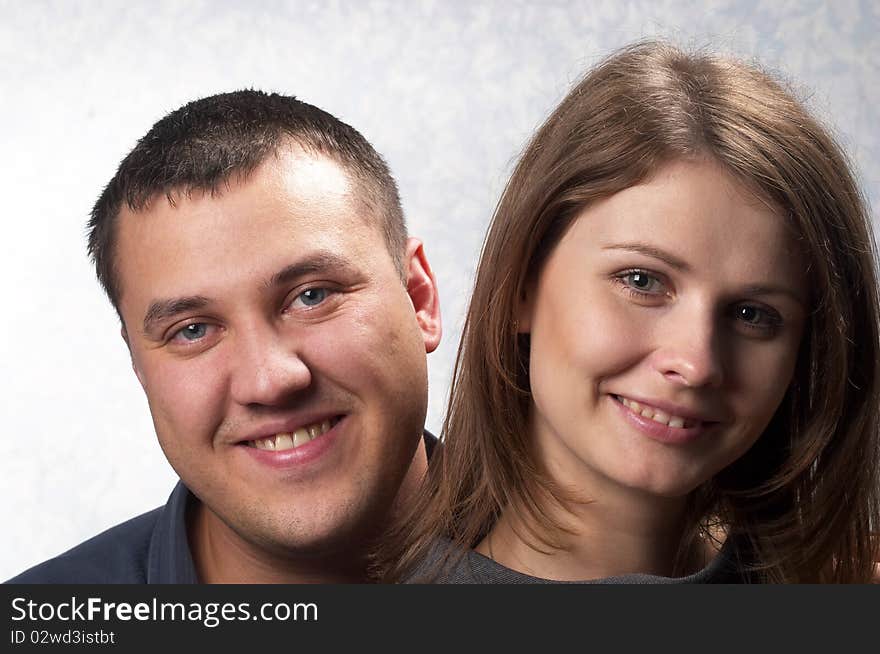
[11,91,441,583]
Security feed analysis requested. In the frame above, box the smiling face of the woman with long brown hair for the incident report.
[519,161,809,498]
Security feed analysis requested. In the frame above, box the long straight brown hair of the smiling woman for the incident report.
[379,42,880,582]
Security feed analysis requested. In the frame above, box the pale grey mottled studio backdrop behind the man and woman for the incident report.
[0,0,880,579]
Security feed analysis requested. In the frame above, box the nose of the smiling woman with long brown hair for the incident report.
[653,305,724,388]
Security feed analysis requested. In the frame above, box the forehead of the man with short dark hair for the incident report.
[117,149,384,312]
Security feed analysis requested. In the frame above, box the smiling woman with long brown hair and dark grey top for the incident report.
[387,43,880,582]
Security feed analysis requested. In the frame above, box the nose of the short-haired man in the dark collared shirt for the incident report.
[231,326,312,406]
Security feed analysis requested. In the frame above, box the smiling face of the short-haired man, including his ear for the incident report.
[116,147,439,554]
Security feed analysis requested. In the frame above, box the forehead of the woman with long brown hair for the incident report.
[560,161,806,290]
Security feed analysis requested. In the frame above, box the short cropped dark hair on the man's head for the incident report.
[88,89,406,317]
